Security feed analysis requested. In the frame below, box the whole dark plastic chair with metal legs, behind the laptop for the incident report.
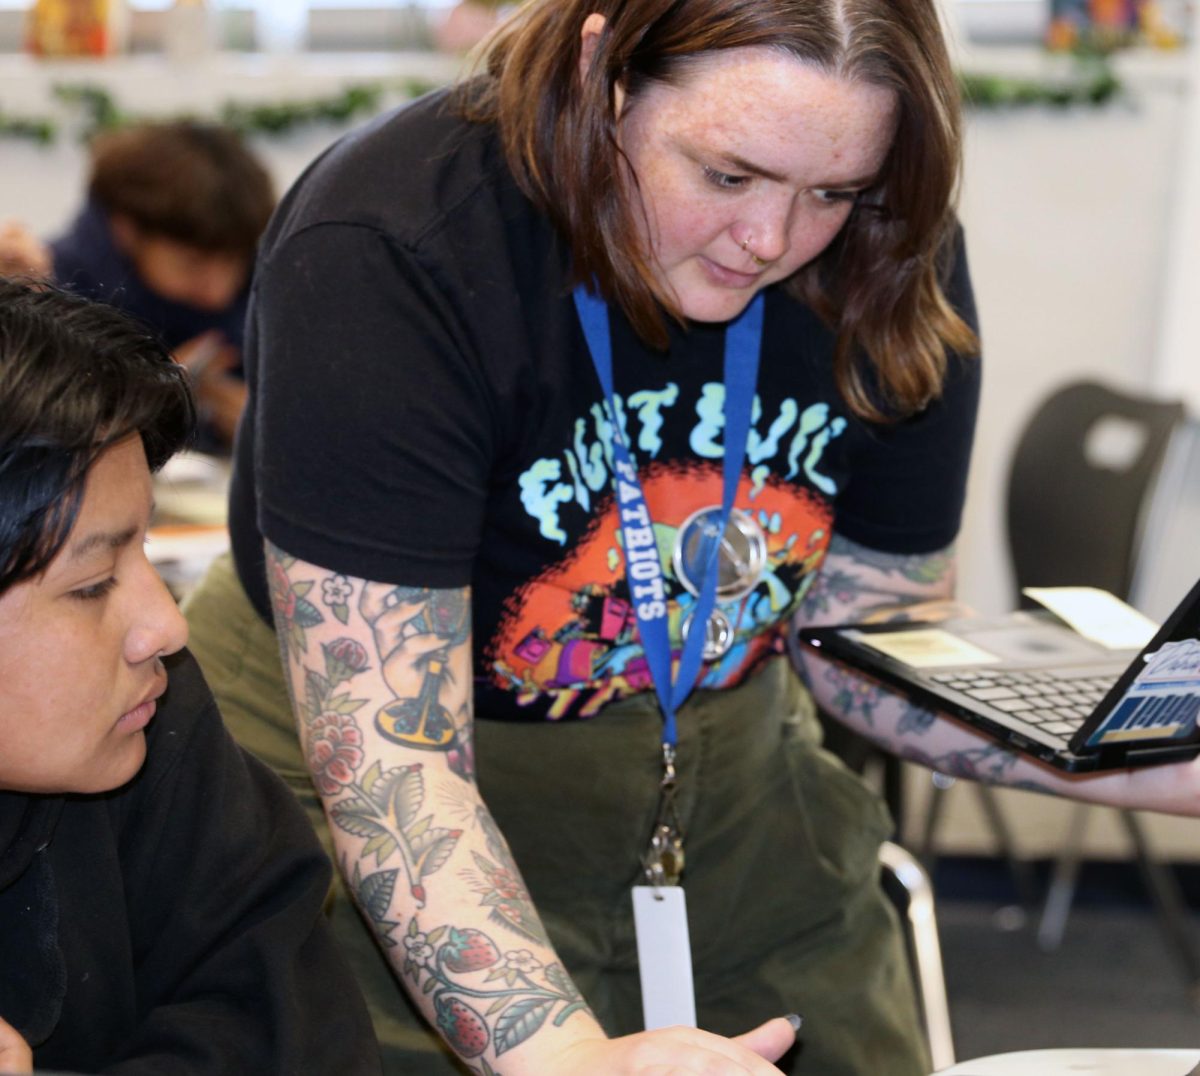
[1007,381,1200,1002]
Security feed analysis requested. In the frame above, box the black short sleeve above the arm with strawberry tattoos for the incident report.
[251,223,493,587]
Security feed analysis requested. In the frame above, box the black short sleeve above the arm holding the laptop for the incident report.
[835,229,982,553]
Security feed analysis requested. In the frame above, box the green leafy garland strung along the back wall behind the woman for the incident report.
[0,56,1121,145]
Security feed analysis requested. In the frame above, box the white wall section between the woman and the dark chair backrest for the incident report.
[959,60,1182,613]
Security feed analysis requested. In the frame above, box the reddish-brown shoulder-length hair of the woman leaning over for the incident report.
[457,0,978,417]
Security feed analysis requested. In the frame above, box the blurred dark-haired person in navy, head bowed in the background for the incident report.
[0,121,275,452]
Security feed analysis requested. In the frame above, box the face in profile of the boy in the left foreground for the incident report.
[0,437,187,793]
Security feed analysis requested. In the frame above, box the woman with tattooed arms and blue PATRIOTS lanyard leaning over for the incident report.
[180,0,1152,1076]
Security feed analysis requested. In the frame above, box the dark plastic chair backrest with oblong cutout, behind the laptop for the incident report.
[1007,381,1184,605]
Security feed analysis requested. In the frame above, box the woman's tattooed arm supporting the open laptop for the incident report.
[796,535,1200,814]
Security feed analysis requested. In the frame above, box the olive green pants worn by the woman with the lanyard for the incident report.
[186,559,929,1076]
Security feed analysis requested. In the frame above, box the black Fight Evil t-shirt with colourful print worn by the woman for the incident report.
[232,86,979,719]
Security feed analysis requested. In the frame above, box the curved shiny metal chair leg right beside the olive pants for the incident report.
[880,841,954,1070]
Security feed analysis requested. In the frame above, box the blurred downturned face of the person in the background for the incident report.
[116,227,250,312]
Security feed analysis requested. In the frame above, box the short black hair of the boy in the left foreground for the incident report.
[0,279,196,595]
